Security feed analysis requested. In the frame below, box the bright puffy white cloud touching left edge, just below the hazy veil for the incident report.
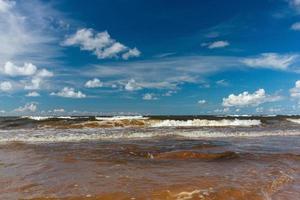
[0,61,37,76]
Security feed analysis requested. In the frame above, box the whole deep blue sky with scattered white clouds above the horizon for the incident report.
[0,0,300,115]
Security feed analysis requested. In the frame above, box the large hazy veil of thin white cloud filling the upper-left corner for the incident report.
[0,0,63,66]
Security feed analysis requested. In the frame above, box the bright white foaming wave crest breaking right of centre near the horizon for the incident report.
[152,119,261,127]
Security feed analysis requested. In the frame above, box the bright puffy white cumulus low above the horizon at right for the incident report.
[222,89,280,107]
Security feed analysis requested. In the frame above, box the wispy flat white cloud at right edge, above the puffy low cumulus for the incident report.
[242,53,299,70]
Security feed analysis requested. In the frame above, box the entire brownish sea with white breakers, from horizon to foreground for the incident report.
[0,116,300,200]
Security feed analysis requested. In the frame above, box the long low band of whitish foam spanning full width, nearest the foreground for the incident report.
[0,129,300,143]
